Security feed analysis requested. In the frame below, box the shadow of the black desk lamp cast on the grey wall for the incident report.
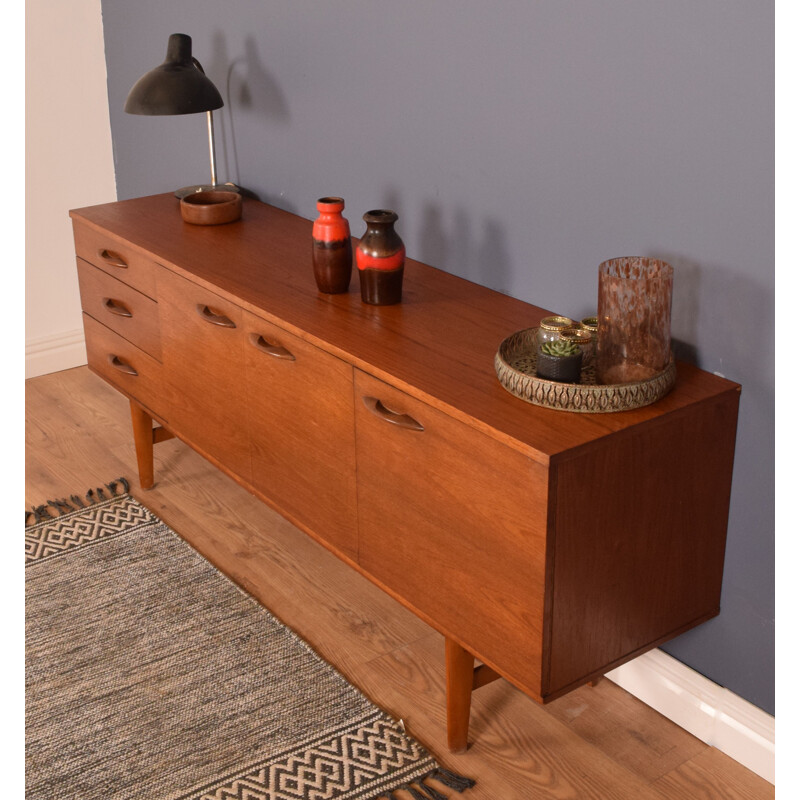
[208,31,291,203]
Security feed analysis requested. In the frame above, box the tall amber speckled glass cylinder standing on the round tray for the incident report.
[597,256,672,384]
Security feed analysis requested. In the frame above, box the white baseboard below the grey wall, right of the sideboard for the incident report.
[606,650,775,784]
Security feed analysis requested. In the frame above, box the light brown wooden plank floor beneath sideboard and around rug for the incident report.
[25,367,774,800]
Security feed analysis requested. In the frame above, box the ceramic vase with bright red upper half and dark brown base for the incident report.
[311,197,353,294]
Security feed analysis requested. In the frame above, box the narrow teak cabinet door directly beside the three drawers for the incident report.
[152,268,250,481]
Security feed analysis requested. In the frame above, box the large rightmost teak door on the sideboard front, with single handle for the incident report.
[355,371,547,695]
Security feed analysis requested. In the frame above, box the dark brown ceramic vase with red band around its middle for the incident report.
[356,209,406,306]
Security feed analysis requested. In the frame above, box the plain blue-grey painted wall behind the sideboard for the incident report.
[103,0,774,713]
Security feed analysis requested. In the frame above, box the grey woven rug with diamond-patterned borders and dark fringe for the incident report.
[25,479,473,800]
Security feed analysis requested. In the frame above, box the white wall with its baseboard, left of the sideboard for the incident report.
[25,0,117,377]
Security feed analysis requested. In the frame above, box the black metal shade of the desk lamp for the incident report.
[125,33,223,116]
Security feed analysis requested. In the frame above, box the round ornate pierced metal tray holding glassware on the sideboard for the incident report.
[494,328,675,414]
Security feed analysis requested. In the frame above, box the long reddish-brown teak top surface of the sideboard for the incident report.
[70,193,740,464]
